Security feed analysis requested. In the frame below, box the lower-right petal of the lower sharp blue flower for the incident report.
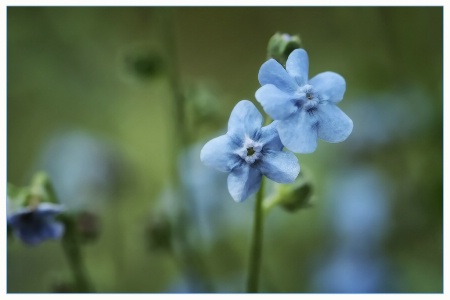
[258,150,300,183]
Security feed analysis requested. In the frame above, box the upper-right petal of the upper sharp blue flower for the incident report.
[309,72,345,103]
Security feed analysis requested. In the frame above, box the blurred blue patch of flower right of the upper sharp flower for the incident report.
[343,85,438,152]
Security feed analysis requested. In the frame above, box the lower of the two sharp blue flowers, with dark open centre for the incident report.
[200,100,300,202]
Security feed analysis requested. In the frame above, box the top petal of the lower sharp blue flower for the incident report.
[228,100,263,141]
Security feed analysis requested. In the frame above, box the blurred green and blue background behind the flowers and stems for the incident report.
[7,7,443,293]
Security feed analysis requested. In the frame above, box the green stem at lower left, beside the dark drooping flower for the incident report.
[62,217,92,293]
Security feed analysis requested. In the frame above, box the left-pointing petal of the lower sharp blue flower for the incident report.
[200,134,240,172]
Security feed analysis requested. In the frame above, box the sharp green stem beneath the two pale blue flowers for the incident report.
[247,177,264,293]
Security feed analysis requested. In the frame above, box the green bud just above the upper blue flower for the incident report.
[267,32,302,65]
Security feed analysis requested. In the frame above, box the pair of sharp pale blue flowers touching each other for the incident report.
[200,49,353,202]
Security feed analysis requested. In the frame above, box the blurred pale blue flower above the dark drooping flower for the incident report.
[33,129,126,212]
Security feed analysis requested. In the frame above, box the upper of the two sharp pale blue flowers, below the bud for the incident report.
[255,49,353,153]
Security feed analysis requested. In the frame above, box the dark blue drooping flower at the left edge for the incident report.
[8,203,64,245]
